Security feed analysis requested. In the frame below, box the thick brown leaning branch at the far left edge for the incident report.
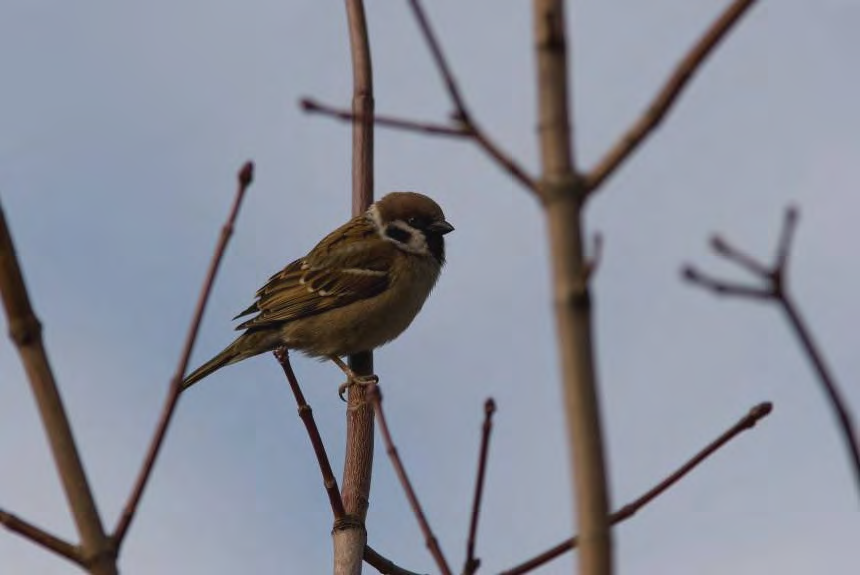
[0,206,117,575]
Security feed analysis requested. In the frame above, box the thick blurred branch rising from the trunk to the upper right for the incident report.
[586,0,756,192]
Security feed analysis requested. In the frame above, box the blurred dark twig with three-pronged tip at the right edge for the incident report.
[683,207,860,500]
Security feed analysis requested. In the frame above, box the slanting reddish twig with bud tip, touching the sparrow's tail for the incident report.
[113,162,254,549]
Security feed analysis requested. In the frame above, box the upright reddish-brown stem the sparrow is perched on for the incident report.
[333,0,373,575]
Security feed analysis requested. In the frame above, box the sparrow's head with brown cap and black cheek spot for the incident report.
[367,192,454,264]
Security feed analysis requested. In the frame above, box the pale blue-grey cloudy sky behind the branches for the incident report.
[0,0,860,575]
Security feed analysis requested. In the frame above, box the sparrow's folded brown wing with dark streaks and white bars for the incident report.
[236,220,397,329]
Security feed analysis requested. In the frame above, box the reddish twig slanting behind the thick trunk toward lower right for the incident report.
[500,402,773,575]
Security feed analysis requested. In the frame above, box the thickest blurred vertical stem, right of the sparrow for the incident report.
[533,0,612,575]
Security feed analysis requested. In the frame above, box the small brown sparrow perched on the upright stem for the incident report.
[182,192,454,397]
